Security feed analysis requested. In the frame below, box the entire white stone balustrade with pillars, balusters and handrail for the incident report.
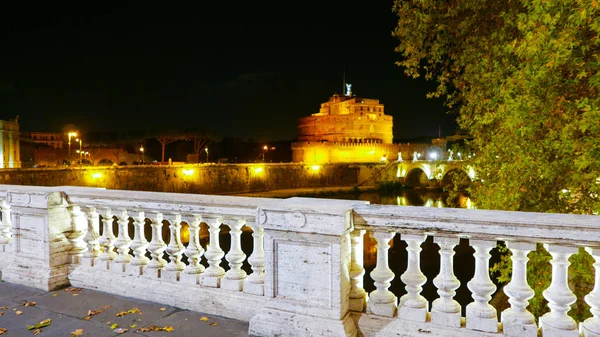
[0,185,600,337]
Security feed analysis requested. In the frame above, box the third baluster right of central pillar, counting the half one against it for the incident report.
[398,234,427,322]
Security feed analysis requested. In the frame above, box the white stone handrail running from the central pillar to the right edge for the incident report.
[354,205,600,246]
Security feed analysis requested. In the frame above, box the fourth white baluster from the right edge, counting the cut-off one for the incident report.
[467,240,498,332]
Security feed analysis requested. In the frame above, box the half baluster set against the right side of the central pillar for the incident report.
[350,230,367,312]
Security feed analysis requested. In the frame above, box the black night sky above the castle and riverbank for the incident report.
[0,0,455,140]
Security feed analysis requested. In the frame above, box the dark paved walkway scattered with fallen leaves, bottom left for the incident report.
[0,282,248,337]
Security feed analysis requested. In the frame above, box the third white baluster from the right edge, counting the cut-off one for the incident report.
[501,242,538,337]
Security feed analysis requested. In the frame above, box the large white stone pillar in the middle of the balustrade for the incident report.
[248,198,357,337]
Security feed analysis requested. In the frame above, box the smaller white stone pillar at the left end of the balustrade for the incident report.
[2,187,72,291]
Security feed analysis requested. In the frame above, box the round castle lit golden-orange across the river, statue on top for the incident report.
[292,84,399,164]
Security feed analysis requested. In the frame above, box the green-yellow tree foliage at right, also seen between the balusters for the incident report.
[393,0,600,319]
